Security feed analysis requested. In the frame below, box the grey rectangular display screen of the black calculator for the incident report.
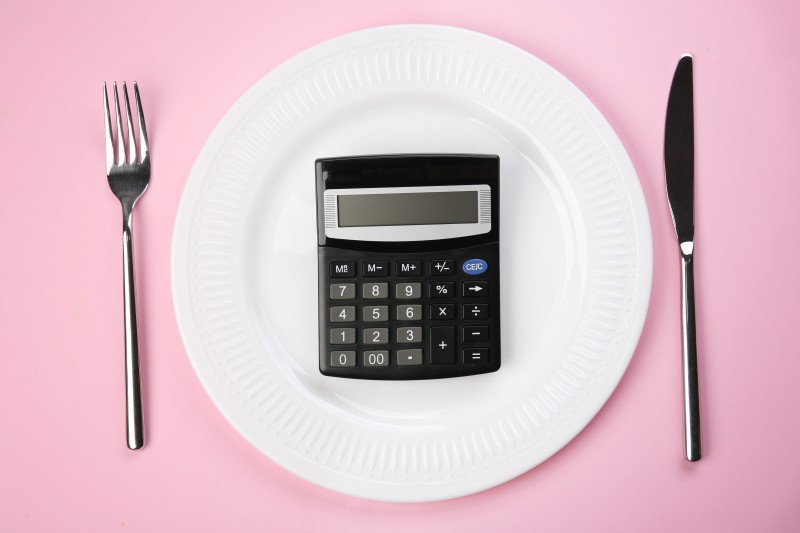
[337,190,478,227]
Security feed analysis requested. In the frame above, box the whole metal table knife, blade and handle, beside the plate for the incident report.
[664,54,701,461]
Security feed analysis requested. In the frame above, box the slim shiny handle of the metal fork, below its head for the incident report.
[122,212,144,450]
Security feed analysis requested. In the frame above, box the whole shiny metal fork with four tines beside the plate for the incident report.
[103,81,150,450]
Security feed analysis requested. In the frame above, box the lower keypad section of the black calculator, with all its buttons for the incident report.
[320,244,500,379]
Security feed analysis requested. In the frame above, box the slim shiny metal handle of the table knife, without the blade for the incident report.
[681,242,701,461]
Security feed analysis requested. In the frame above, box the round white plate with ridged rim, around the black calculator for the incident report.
[172,26,652,501]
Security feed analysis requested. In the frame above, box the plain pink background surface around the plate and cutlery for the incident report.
[0,0,800,532]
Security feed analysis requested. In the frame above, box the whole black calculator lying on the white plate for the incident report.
[316,154,500,380]
